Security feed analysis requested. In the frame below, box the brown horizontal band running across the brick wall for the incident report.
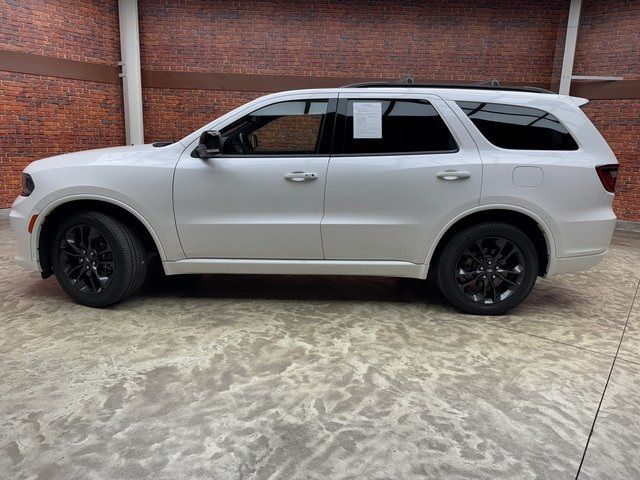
[0,50,640,100]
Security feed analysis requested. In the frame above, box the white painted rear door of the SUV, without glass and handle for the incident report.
[322,90,482,263]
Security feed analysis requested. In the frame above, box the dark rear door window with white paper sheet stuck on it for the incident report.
[344,99,458,154]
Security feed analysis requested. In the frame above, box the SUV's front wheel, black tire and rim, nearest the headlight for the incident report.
[51,211,147,307]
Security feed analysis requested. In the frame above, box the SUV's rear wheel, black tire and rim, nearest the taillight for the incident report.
[435,222,538,315]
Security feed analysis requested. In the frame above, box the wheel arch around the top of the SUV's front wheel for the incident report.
[31,196,166,278]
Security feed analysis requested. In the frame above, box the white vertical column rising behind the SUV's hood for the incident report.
[118,0,144,145]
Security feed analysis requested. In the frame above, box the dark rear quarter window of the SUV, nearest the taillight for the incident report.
[457,102,578,150]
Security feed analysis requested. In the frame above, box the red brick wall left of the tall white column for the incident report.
[0,0,124,208]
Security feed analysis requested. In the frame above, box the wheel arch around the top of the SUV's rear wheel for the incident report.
[427,205,555,277]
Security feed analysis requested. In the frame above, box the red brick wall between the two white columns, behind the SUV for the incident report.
[139,0,568,141]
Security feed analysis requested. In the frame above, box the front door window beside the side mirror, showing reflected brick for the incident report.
[221,100,327,155]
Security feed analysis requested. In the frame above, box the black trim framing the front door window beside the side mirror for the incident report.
[208,96,338,158]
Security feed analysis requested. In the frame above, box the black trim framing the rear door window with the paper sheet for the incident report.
[331,96,460,157]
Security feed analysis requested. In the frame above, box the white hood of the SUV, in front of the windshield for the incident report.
[25,144,156,172]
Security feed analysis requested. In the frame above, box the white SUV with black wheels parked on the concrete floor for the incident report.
[10,84,618,314]
